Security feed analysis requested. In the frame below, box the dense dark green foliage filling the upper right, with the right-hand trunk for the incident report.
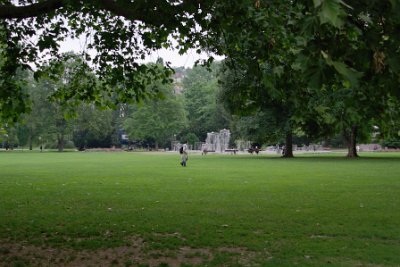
[209,0,400,157]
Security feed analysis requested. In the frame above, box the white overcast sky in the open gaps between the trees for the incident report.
[60,39,222,68]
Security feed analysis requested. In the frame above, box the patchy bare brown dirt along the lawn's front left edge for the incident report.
[0,237,268,267]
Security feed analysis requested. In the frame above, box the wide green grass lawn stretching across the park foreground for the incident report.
[0,151,400,266]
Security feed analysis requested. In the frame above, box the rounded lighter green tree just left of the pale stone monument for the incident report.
[124,76,187,149]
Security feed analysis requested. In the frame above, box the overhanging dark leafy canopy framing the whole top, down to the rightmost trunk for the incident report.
[0,0,400,156]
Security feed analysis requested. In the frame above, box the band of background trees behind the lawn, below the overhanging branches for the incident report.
[0,54,399,154]
